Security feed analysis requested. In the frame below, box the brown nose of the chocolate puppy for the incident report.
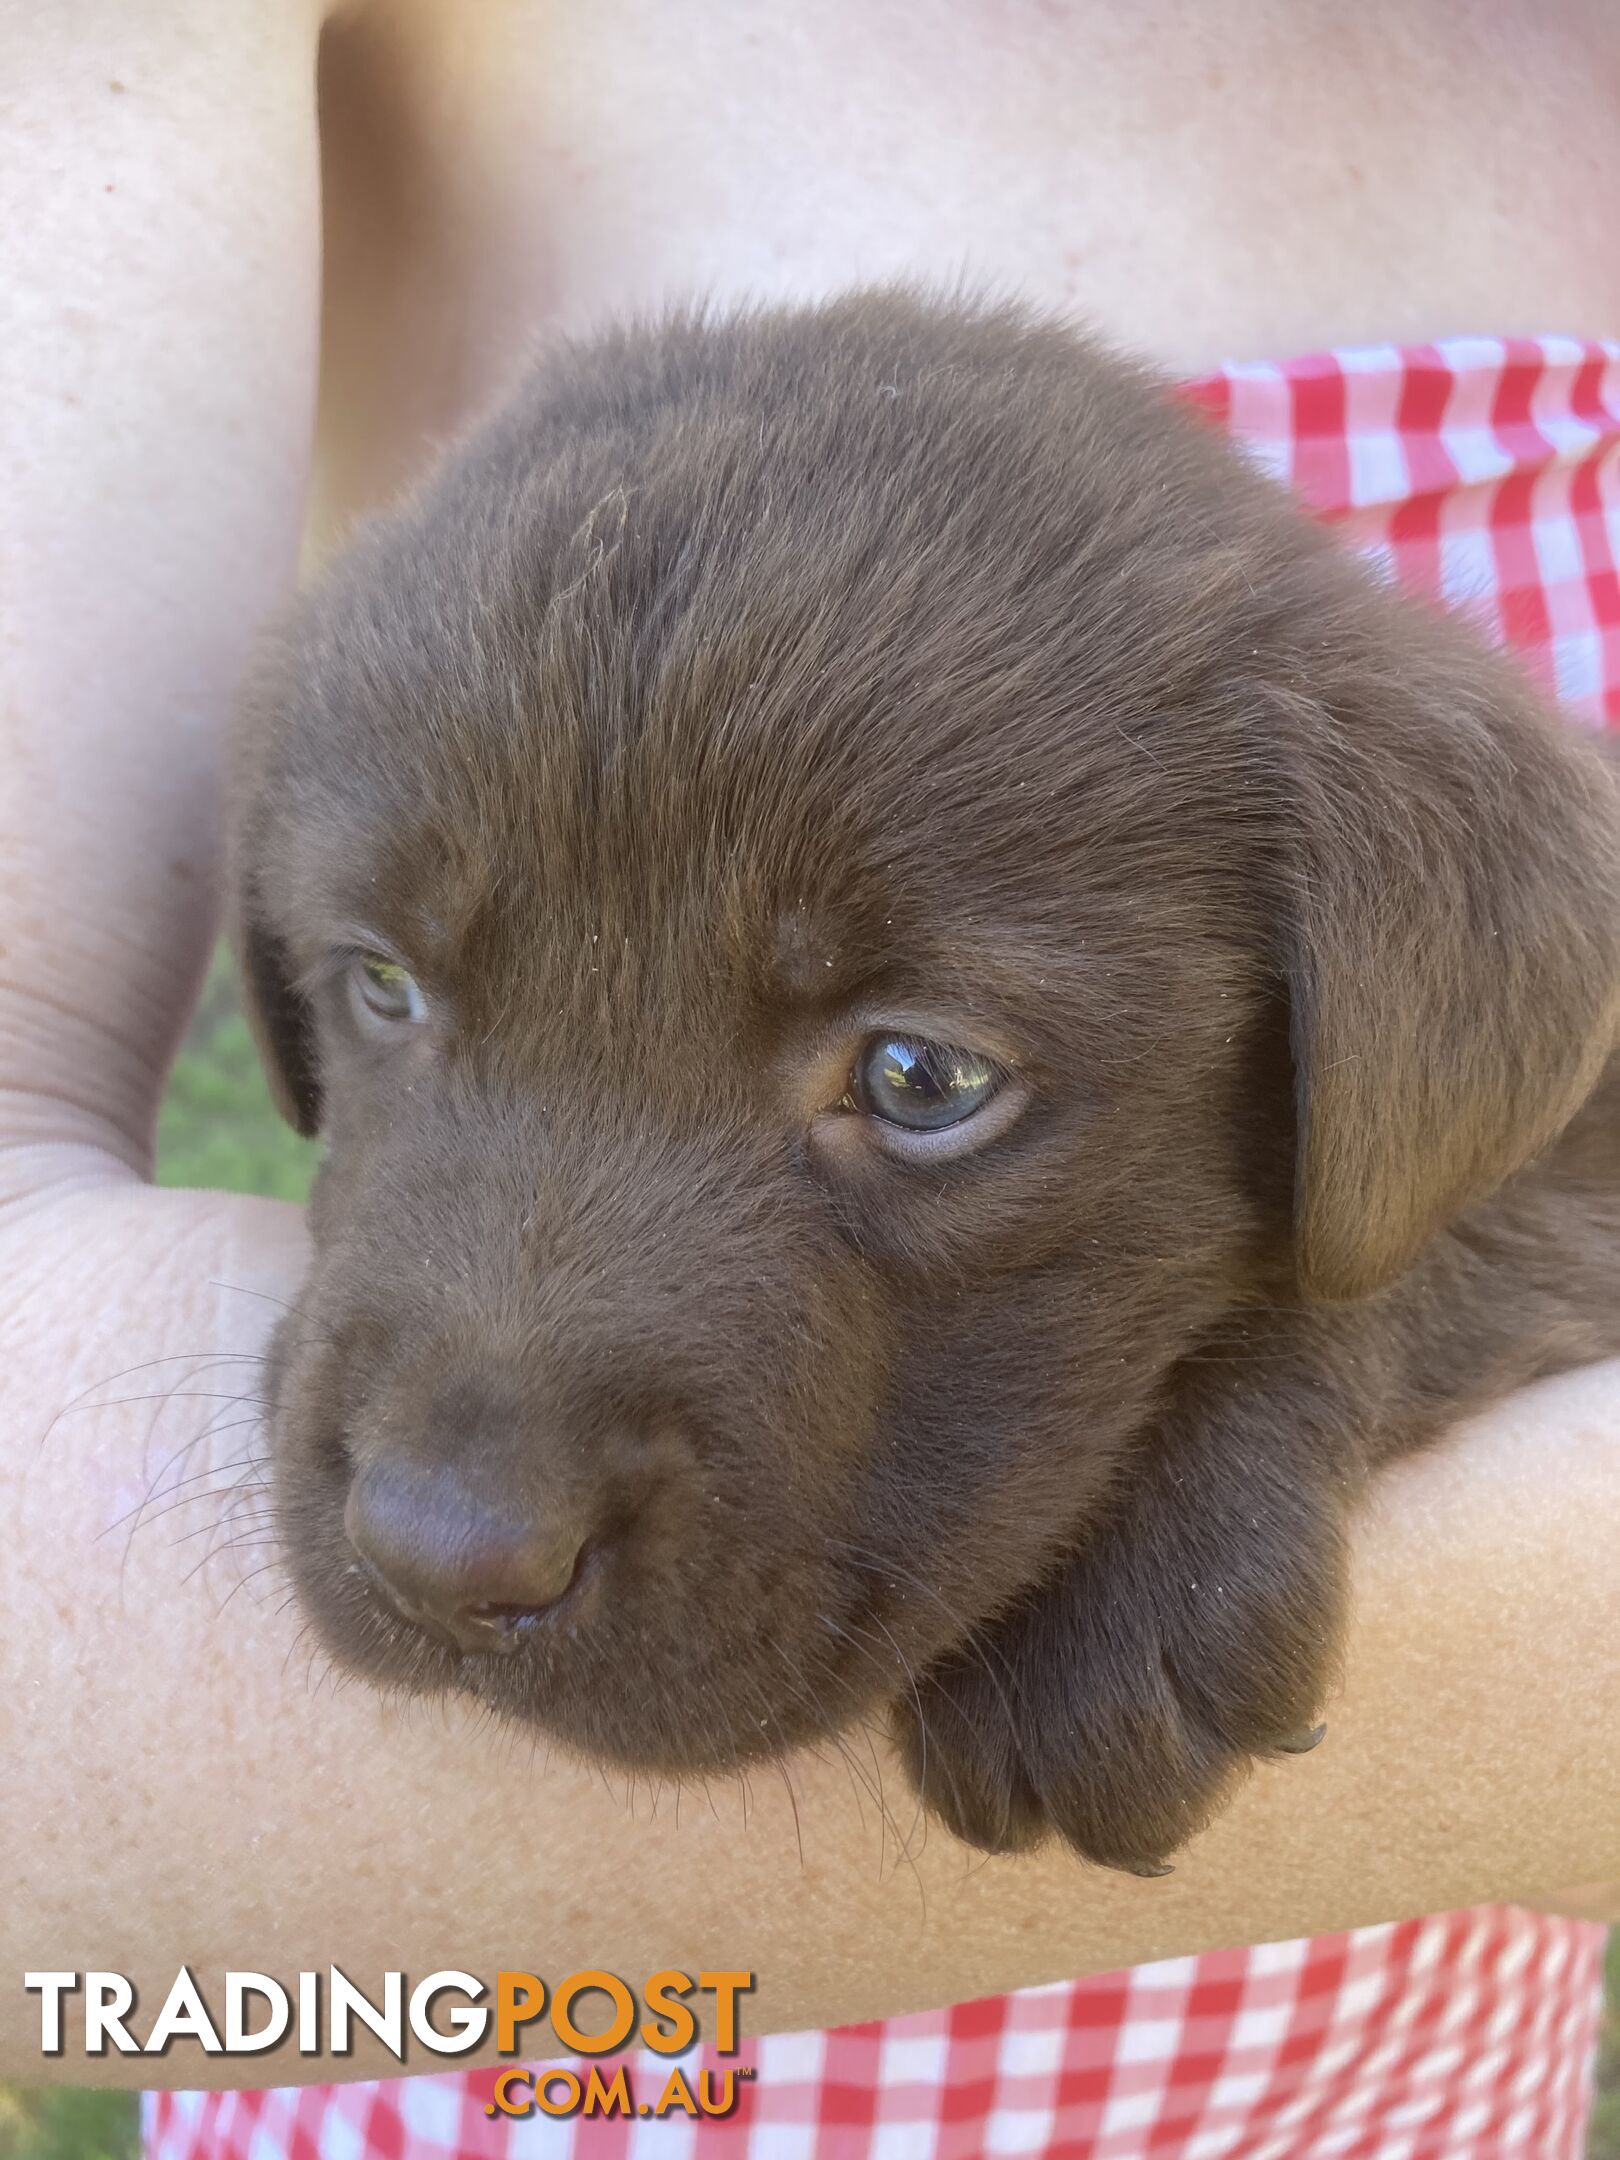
[343,1460,585,1650]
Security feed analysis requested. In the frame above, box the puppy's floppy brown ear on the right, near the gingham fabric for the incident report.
[1279,626,1620,1298]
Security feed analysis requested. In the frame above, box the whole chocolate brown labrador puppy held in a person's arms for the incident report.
[235,294,1620,1873]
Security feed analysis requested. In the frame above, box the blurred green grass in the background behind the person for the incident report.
[0,959,1620,2160]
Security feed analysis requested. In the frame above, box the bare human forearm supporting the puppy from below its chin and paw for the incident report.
[0,1186,1620,2082]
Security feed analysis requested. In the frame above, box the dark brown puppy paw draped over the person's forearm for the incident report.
[896,1425,1341,1875]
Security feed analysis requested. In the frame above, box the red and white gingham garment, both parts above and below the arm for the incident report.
[145,337,1620,2160]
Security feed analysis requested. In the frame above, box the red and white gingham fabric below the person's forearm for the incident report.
[147,1905,1603,2160]
